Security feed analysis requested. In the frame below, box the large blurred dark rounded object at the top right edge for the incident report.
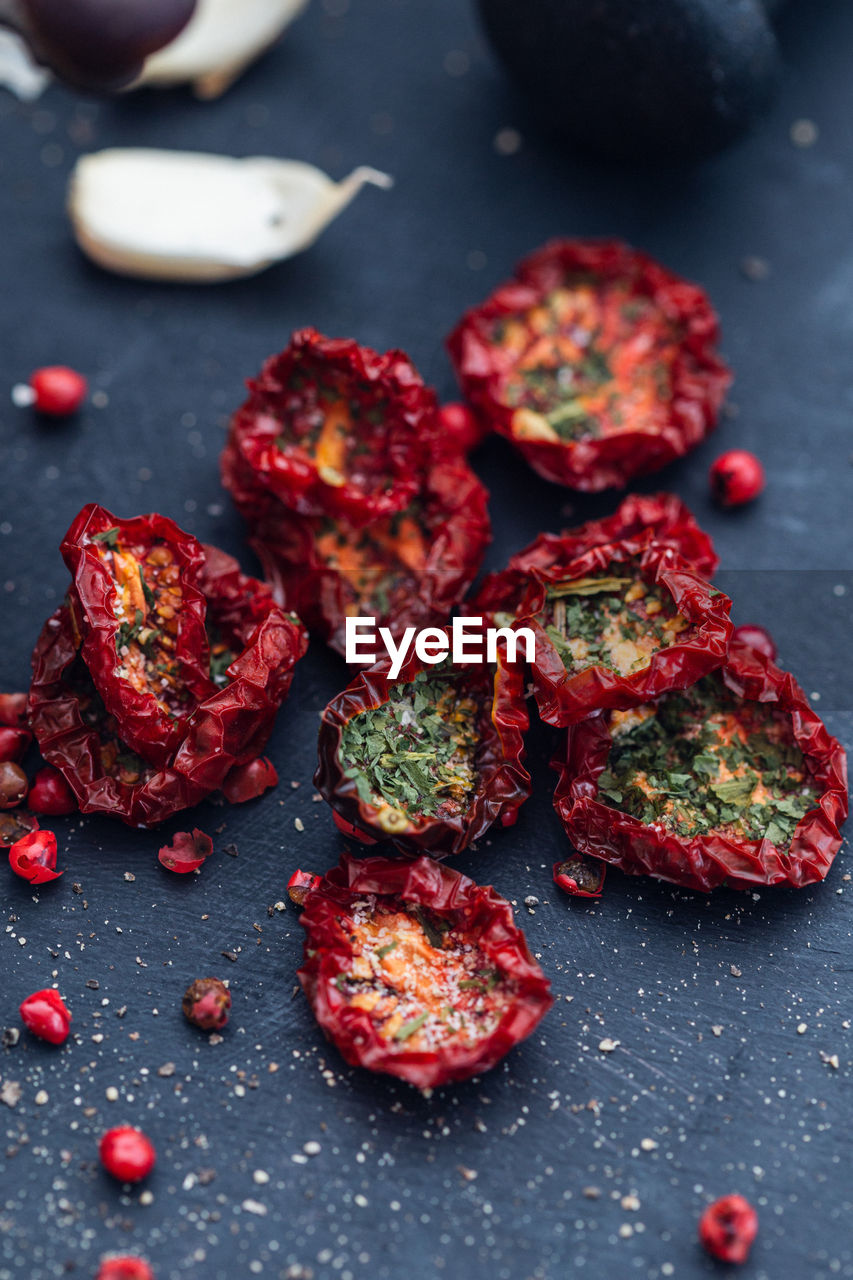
[478,0,779,160]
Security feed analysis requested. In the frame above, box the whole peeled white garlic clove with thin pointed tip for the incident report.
[68,147,392,283]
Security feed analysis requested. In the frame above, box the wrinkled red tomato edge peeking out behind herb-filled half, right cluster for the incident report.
[466,493,720,614]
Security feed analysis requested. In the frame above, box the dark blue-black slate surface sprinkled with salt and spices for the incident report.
[0,0,853,1280]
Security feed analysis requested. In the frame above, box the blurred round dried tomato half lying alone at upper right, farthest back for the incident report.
[448,241,730,490]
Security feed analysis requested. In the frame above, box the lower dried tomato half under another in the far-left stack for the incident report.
[29,524,307,826]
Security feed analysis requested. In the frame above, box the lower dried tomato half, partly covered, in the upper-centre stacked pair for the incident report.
[250,460,491,654]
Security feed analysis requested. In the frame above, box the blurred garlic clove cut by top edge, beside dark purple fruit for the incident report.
[133,0,307,97]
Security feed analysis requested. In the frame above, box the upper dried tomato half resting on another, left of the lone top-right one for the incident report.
[222,329,438,524]
